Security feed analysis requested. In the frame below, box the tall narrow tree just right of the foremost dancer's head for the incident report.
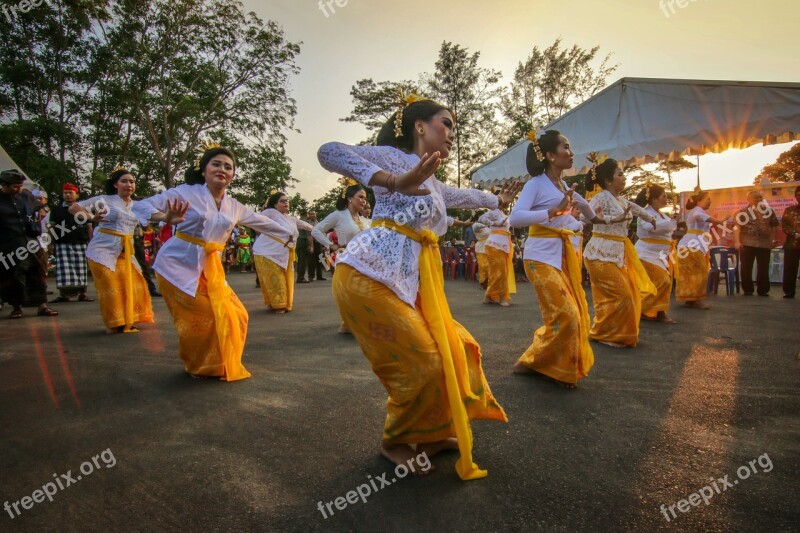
[426,41,502,187]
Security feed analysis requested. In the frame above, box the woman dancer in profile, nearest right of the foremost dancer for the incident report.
[509,130,615,389]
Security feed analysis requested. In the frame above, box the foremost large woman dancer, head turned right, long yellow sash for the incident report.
[318,94,518,480]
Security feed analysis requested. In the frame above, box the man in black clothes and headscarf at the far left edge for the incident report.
[0,170,58,318]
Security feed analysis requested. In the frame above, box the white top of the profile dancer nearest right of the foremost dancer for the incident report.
[508,174,594,270]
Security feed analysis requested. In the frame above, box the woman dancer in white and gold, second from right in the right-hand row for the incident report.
[635,181,678,324]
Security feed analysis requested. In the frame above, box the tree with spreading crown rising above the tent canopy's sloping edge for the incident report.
[500,38,618,146]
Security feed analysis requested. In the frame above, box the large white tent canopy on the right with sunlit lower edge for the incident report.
[472,78,800,187]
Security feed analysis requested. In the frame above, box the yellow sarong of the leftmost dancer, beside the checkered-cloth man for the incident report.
[87,255,153,332]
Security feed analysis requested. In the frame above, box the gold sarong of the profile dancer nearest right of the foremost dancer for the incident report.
[519,260,594,383]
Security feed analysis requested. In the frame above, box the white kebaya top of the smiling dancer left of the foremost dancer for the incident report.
[133,184,292,297]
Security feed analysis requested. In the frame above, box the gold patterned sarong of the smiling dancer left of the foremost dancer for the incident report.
[156,274,250,379]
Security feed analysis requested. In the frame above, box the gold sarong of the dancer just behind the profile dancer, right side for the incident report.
[585,259,650,346]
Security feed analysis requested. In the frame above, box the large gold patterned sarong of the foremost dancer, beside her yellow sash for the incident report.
[333,264,508,444]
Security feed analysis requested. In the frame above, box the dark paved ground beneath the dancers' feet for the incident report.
[0,274,800,531]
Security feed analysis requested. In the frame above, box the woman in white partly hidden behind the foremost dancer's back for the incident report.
[311,180,372,333]
